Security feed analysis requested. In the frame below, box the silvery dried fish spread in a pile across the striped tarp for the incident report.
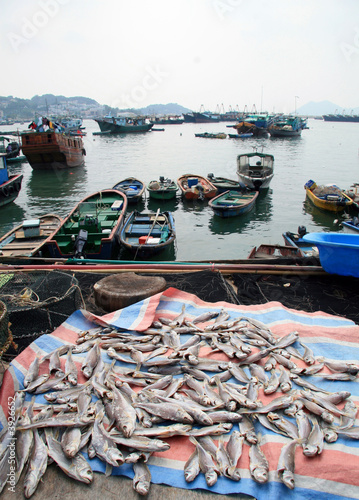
[0,306,359,498]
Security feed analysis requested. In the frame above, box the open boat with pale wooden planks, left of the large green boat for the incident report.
[0,214,62,257]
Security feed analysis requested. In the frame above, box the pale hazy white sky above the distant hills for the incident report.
[0,0,359,112]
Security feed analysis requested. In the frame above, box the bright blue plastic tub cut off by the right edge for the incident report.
[303,233,359,278]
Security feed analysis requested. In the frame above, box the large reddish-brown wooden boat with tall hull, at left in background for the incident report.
[21,129,86,170]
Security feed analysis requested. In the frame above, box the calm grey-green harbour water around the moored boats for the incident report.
[0,119,359,261]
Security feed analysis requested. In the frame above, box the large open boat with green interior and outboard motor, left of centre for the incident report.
[46,189,127,259]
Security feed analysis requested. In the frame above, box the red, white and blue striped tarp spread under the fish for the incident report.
[0,288,359,500]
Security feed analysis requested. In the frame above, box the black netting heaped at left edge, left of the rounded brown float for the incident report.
[0,271,83,356]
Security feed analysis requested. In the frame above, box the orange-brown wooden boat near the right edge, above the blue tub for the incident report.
[304,179,354,212]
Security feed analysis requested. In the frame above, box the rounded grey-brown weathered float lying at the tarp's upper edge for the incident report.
[93,272,167,312]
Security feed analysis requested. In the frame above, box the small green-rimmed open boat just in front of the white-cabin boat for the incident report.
[209,191,259,218]
